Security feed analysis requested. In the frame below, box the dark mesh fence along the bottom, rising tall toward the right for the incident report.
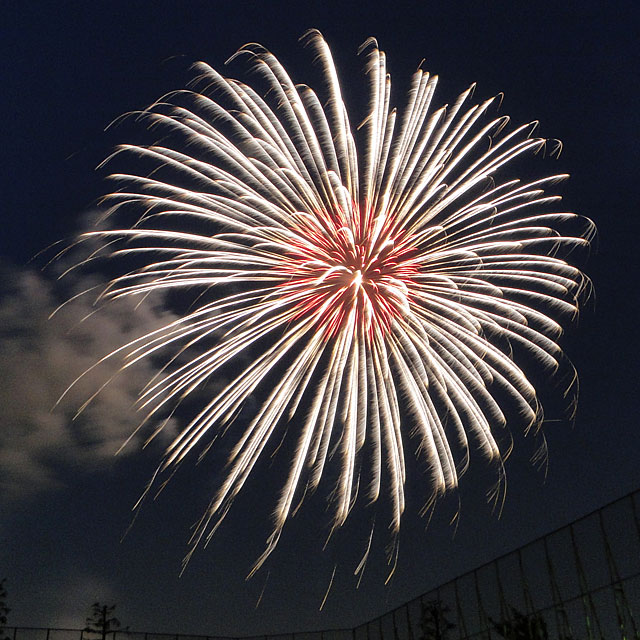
[4,491,640,640]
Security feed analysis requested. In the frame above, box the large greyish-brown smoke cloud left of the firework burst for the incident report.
[0,268,179,499]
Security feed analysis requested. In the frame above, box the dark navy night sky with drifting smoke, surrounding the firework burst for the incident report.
[0,0,640,635]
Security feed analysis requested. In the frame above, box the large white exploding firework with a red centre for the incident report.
[70,31,591,566]
